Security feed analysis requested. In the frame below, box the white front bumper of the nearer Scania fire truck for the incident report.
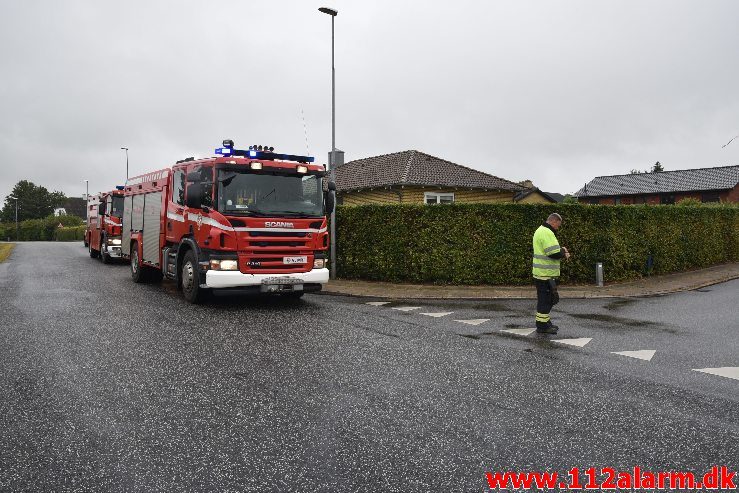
[203,269,328,293]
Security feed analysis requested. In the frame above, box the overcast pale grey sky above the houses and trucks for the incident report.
[0,0,739,199]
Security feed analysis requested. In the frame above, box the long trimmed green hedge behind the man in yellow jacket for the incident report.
[336,204,739,284]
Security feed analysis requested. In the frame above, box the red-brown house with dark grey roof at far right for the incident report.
[575,166,739,205]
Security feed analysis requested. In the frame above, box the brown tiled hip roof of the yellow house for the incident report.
[336,151,525,192]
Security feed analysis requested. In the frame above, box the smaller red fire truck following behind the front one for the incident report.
[84,187,123,264]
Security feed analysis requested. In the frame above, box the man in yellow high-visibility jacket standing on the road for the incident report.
[531,212,570,334]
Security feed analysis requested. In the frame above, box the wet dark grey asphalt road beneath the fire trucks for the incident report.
[0,243,739,492]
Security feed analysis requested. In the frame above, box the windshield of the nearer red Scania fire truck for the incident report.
[218,170,323,217]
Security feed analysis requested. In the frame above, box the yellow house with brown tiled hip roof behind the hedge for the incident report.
[336,150,525,205]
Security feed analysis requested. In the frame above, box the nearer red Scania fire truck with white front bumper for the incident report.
[122,140,336,303]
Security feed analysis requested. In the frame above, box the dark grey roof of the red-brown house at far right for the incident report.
[575,166,739,197]
